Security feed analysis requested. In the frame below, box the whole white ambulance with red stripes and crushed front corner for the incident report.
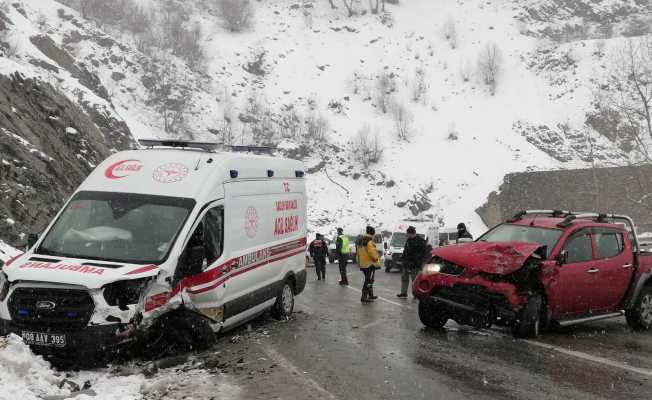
[0,141,306,354]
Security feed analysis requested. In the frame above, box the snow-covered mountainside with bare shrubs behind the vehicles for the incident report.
[0,0,652,250]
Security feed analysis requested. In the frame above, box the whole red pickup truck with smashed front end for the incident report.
[412,210,652,337]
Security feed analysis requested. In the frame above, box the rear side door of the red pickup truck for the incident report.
[591,228,634,312]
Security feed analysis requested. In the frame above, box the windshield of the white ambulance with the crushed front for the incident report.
[37,192,195,264]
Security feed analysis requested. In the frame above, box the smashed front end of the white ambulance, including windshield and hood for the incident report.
[0,191,200,362]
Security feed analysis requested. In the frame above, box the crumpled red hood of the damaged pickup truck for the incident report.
[432,242,542,275]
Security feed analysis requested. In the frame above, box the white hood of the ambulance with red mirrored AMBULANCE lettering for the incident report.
[2,255,160,289]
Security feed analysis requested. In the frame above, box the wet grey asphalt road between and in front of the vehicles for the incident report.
[227,265,652,400]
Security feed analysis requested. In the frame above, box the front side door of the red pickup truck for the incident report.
[548,229,597,318]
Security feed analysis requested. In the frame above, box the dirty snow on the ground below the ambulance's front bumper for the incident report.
[0,335,239,400]
